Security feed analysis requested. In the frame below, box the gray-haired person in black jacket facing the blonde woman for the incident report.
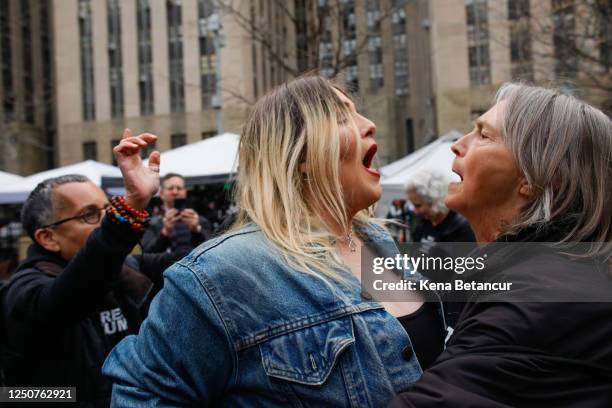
[390,84,612,408]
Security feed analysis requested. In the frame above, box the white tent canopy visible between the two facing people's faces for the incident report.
[376,130,462,216]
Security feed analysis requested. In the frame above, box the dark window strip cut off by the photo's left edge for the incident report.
[0,1,15,120]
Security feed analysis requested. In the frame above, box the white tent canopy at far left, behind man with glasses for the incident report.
[0,160,121,204]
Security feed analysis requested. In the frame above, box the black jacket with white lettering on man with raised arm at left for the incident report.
[0,220,184,407]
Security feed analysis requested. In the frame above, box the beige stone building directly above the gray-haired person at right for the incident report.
[429,0,612,134]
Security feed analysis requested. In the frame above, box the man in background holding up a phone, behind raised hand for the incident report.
[142,173,211,252]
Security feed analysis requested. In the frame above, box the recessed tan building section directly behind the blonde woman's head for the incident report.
[243,0,436,164]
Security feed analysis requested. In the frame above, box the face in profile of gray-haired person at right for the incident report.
[445,102,524,222]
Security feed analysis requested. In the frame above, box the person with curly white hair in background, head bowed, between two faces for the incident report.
[406,170,474,242]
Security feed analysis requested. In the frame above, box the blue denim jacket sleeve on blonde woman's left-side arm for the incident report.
[102,264,236,407]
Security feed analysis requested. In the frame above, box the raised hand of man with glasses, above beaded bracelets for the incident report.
[113,129,159,210]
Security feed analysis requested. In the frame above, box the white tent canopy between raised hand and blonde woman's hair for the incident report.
[104,133,240,192]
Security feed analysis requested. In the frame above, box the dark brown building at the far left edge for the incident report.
[0,0,55,175]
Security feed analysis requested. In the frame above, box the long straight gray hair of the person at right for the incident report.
[496,83,612,258]
